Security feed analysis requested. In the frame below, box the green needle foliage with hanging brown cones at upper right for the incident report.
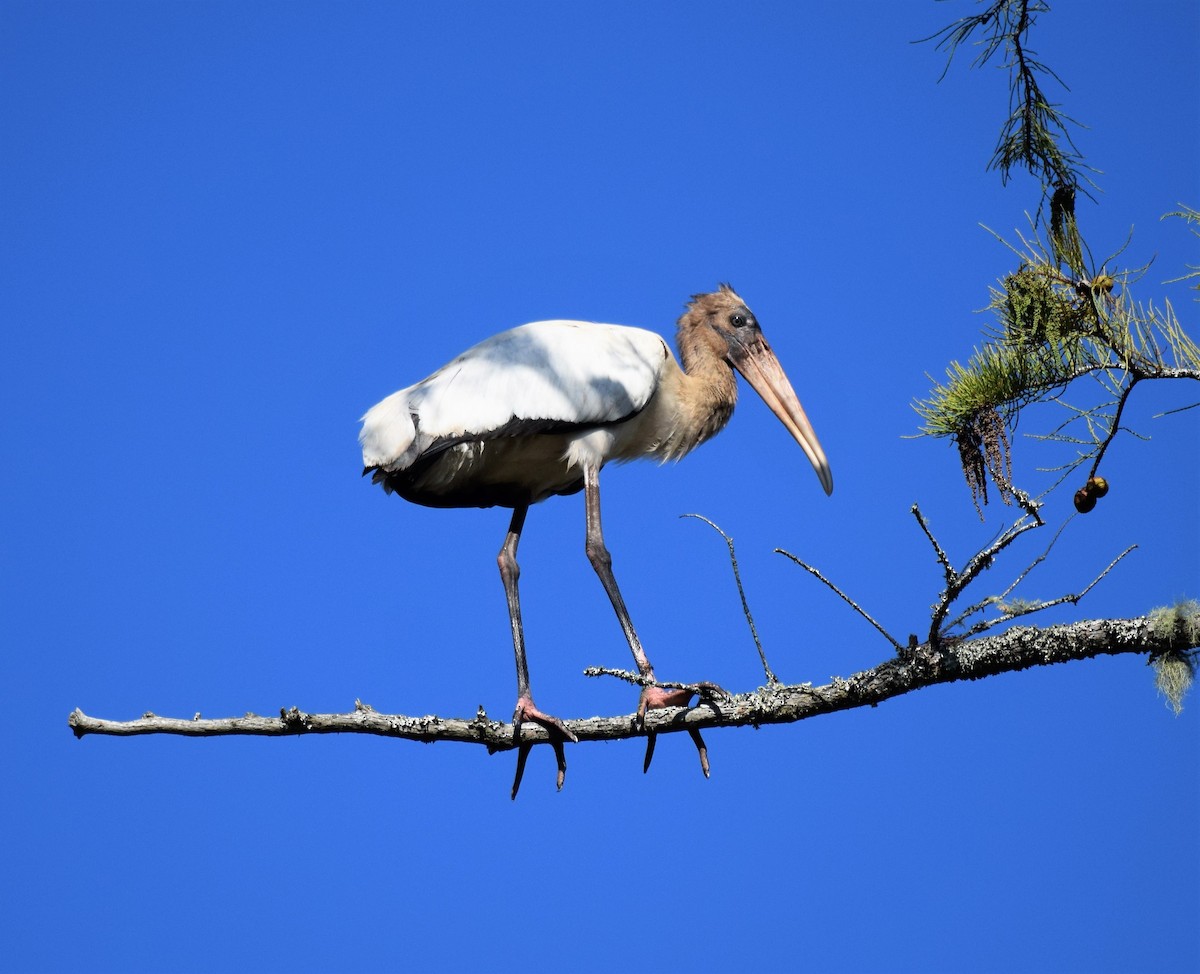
[914,0,1200,510]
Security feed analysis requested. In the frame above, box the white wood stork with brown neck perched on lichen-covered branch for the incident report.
[359,284,833,798]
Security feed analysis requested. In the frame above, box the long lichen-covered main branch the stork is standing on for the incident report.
[68,603,1200,752]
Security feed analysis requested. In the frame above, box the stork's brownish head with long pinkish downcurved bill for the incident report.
[679,284,833,494]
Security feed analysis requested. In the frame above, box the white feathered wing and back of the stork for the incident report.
[359,320,670,469]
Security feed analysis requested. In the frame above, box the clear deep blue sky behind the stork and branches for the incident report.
[0,0,1200,972]
